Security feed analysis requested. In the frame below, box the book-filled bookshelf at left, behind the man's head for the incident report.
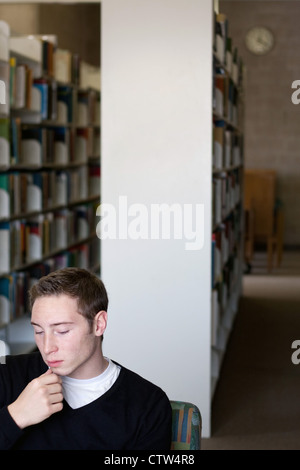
[0,22,100,353]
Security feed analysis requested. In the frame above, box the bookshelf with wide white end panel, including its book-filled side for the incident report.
[101,0,243,437]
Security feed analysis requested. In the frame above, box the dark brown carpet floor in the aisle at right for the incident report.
[202,252,300,450]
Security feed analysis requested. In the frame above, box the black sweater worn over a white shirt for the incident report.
[0,353,171,450]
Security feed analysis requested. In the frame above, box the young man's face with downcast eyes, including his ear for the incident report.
[31,294,106,379]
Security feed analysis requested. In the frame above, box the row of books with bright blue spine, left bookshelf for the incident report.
[0,38,100,126]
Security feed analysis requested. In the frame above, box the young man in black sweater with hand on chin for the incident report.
[0,268,171,450]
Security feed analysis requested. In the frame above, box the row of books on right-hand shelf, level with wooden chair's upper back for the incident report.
[212,168,242,228]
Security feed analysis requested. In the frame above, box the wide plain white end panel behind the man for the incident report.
[101,0,212,436]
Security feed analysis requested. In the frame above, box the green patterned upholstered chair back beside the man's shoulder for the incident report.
[170,400,202,450]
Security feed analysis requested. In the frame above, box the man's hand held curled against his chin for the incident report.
[8,369,63,429]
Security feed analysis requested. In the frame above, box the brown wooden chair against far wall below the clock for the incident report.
[244,169,284,271]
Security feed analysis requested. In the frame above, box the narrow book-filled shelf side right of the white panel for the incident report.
[211,7,245,398]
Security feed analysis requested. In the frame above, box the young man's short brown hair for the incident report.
[29,268,108,325]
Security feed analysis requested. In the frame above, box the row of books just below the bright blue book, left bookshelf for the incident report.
[0,118,100,166]
